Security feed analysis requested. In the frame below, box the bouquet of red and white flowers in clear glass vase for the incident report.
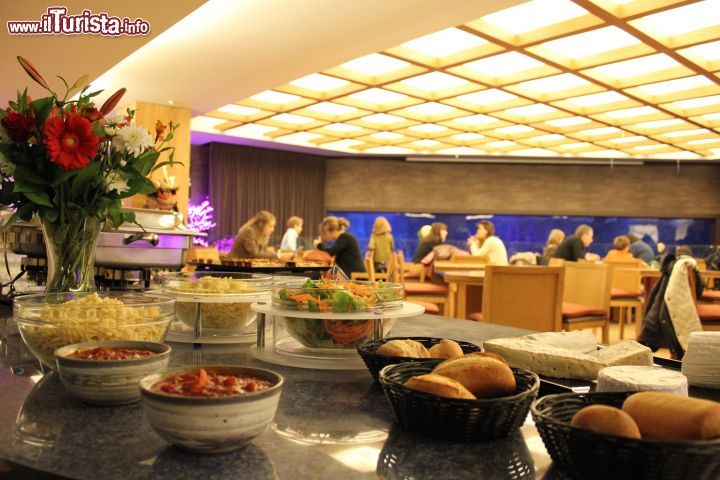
[0,57,176,292]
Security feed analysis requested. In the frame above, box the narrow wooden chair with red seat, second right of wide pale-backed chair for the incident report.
[603,260,643,340]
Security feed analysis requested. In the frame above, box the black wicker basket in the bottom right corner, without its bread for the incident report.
[531,392,720,480]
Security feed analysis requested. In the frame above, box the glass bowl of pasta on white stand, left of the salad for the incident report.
[162,271,272,336]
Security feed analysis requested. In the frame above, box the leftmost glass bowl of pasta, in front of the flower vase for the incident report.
[13,292,175,370]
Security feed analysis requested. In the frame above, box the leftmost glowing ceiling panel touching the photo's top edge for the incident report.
[482,0,588,35]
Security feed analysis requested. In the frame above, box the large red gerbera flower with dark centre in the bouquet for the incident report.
[43,113,100,170]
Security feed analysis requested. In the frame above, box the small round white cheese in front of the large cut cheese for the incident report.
[595,365,688,397]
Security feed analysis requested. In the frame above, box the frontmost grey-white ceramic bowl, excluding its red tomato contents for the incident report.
[140,365,283,453]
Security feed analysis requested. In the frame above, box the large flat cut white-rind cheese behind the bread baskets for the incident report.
[483,337,652,380]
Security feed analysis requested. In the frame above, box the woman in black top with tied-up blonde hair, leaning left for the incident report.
[313,216,365,277]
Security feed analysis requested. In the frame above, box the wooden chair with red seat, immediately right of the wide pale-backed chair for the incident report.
[563,262,612,344]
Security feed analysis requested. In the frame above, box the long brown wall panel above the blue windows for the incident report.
[325,159,720,217]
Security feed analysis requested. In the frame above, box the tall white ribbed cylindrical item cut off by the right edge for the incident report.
[682,332,720,389]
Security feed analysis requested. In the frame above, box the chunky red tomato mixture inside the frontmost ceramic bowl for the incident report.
[152,368,272,397]
